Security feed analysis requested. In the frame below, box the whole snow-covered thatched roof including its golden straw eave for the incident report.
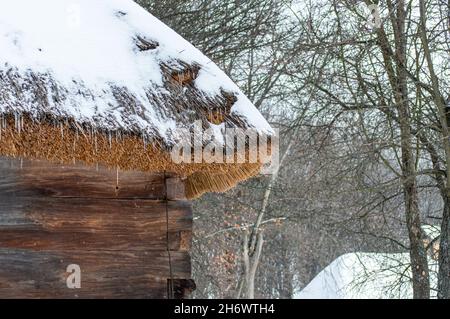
[0,0,271,196]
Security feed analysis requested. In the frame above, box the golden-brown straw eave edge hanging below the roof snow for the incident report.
[0,114,261,199]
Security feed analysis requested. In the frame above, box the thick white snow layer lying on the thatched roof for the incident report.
[0,0,272,141]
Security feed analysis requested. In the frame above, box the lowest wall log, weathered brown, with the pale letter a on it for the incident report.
[0,249,190,298]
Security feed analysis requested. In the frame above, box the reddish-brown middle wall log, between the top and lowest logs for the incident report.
[0,195,192,251]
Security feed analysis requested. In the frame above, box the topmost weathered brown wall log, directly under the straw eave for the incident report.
[0,157,185,199]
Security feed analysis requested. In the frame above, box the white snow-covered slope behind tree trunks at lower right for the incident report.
[295,226,439,299]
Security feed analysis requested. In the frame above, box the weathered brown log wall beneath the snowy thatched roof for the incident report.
[0,157,193,298]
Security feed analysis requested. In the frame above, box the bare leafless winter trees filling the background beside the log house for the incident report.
[137,0,450,298]
